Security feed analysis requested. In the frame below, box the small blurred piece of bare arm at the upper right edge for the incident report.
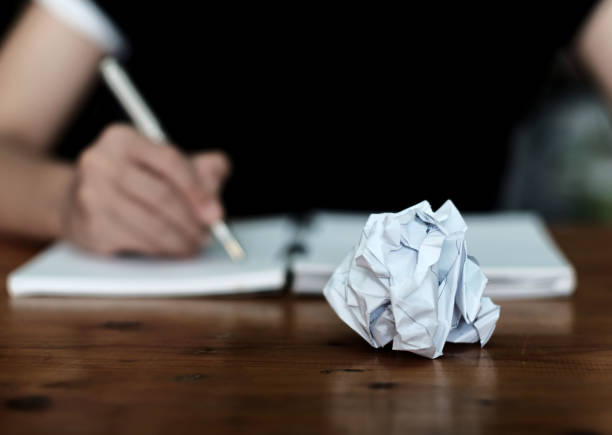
[576,0,612,106]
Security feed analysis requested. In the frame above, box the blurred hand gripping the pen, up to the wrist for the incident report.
[64,125,229,256]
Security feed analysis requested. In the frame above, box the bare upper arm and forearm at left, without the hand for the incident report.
[0,4,103,238]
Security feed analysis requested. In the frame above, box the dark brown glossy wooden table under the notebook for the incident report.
[0,227,612,435]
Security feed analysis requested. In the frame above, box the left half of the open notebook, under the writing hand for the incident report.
[8,217,294,296]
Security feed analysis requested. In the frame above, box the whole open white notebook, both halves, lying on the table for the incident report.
[8,212,575,299]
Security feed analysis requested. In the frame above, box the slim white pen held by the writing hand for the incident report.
[100,57,245,261]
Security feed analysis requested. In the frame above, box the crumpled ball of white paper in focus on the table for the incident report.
[324,201,499,358]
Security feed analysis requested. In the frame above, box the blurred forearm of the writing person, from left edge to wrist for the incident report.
[0,135,74,239]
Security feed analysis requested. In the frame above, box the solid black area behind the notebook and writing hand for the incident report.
[0,0,592,215]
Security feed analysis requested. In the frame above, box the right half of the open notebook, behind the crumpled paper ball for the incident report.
[292,212,575,299]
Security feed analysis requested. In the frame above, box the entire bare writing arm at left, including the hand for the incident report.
[0,4,229,256]
